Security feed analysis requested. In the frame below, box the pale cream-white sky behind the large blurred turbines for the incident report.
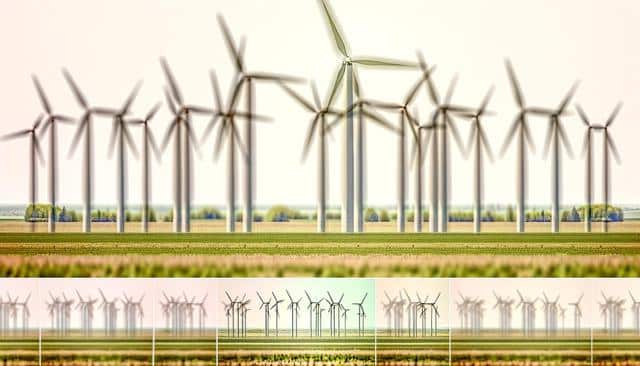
[0,0,640,205]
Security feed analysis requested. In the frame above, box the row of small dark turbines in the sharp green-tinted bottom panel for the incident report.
[222,289,368,338]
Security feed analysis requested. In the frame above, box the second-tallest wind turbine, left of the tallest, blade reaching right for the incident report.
[218,14,302,232]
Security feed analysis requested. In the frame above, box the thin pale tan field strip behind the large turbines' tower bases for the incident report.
[0,220,640,233]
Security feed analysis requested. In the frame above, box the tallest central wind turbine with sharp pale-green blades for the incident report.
[320,0,414,232]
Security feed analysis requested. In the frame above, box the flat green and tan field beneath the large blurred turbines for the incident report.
[0,222,640,277]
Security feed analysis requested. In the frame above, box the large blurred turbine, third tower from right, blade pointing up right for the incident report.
[544,83,578,233]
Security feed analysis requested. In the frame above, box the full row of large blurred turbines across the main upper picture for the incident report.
[3,0,621,233]
